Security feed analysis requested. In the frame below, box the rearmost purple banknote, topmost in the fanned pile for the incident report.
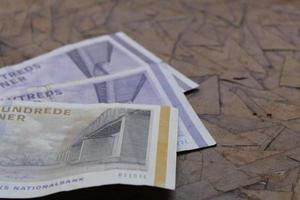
[0,31,198,93]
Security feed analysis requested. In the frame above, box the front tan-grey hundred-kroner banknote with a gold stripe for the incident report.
[0,101,178,198]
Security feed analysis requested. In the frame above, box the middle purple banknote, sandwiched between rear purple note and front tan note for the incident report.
[0,68,214,151]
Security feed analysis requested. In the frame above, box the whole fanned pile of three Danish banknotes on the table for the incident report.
[0,33,215,198]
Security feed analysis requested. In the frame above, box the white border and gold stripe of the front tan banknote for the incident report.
[0,101,178,198]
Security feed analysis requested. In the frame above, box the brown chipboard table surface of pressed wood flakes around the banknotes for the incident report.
[0,0,300,200]
